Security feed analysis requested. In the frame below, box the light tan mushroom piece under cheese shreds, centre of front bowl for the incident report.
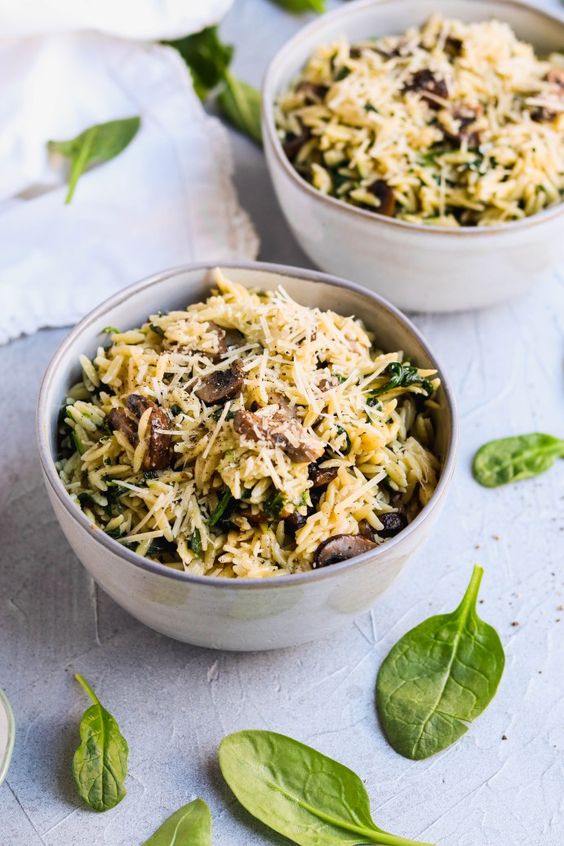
[233,409,325,463]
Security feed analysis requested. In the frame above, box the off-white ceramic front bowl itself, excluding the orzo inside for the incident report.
[37,264,456,650]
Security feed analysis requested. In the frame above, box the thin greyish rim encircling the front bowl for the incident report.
[36,260,458,590]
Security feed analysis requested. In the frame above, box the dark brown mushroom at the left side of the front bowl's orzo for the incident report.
[108,394,174,470]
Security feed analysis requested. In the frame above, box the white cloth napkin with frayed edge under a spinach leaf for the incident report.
[0,0,258,343]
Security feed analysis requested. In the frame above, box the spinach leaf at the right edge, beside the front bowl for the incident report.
[472,432,564,488]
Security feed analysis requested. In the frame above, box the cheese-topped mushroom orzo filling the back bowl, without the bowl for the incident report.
[275,15,564,227]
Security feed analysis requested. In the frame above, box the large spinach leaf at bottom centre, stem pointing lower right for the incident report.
[219,731,432,846]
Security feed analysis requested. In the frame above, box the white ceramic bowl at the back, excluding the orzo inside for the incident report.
[262,0,564,311]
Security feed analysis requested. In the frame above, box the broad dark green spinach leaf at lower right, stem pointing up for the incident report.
[376,566,505,759]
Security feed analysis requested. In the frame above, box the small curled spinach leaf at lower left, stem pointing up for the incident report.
[72,673,129,811]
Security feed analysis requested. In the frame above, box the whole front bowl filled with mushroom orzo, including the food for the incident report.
[38,264,456,650]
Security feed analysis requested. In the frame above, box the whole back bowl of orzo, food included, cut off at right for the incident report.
[263,0,564,311]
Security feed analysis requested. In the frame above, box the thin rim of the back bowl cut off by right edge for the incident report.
[261,0,564,238]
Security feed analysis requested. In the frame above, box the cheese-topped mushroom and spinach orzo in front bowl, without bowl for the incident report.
[57,270,440,577]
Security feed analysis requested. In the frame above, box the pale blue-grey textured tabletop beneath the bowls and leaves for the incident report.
[0,0,564,846]
